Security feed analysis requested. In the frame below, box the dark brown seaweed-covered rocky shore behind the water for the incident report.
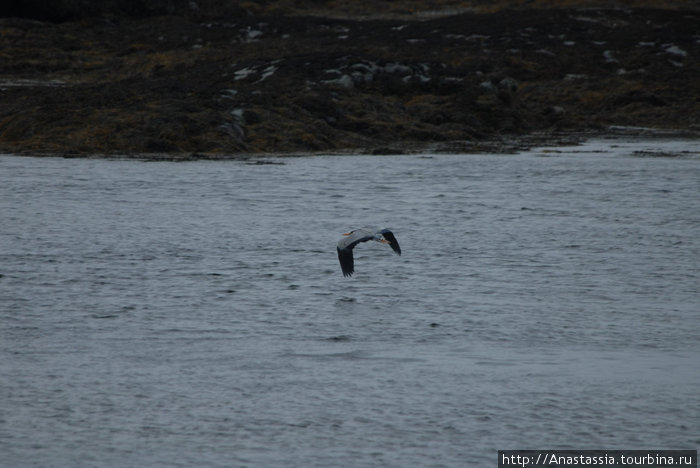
[0,2,700,159]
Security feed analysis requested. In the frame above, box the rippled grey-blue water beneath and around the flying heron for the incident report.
[0,141,700,467]
